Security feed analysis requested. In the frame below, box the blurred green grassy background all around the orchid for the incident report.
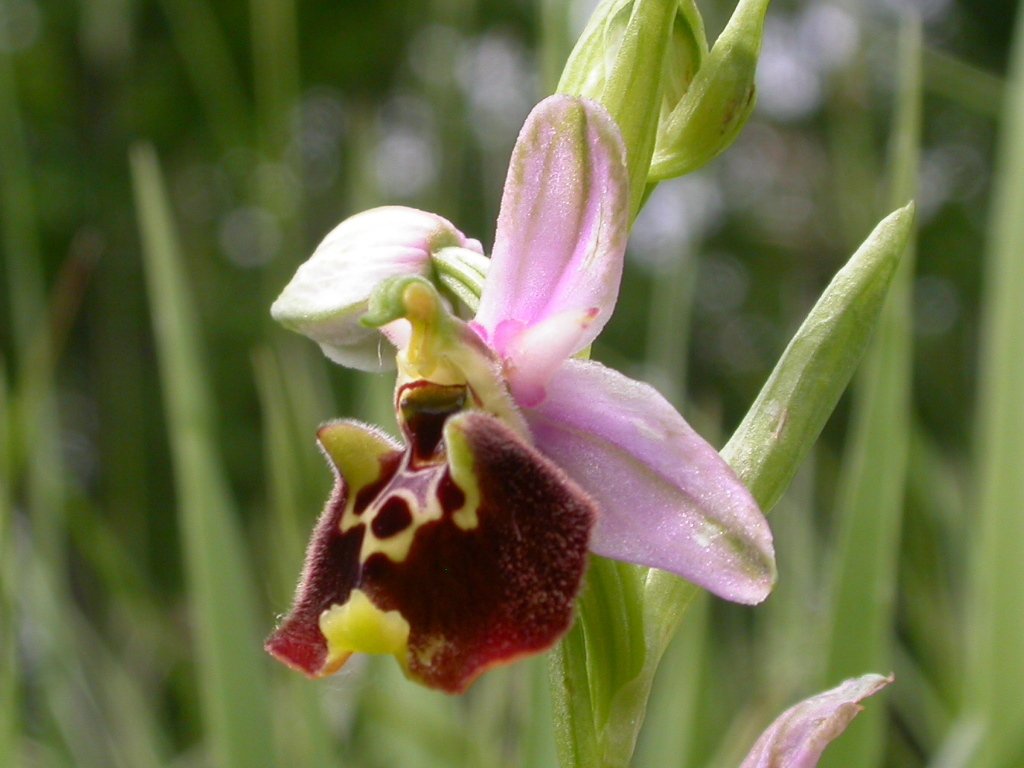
[0,0,1024,768]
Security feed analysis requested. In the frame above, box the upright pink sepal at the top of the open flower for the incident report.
[476,96,629,364]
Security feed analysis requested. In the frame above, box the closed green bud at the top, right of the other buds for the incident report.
[648,0,769,182]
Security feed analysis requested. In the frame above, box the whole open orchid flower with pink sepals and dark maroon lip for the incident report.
[267,96,774,692]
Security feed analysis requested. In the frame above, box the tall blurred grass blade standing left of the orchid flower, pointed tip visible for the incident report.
[131,146,275,768]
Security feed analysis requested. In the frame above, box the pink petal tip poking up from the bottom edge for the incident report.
[740,675,893,768]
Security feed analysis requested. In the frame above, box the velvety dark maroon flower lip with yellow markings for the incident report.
[266,411,597,693]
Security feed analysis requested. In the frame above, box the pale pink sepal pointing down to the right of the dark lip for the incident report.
[523,360,775,603]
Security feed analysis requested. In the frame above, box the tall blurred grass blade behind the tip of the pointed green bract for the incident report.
[823,15,922,768]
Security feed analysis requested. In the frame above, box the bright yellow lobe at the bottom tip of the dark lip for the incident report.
[319,589,409,667]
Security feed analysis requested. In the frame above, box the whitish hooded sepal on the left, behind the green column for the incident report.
[270,206,482,371]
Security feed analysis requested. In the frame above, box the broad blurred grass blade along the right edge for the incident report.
[966,1,1024,768]
